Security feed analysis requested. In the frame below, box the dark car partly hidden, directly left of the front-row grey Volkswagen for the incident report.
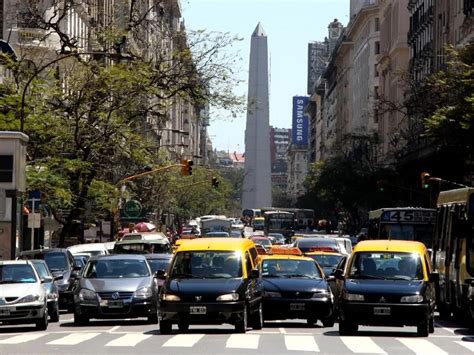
[18,248,81,311]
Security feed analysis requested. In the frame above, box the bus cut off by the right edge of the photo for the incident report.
[433,187,474,321]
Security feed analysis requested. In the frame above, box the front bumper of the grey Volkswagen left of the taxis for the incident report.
[74,299,157,319]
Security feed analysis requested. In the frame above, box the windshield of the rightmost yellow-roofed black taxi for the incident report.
[349,252,423,280]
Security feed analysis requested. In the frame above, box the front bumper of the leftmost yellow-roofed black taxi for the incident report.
[159,301,245,324]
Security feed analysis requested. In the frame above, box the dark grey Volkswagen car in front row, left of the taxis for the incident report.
[74,255,158,325]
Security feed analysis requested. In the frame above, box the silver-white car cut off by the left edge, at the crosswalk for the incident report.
[0,260,48,330]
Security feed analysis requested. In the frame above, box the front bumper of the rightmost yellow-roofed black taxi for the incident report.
[339,302,432,326]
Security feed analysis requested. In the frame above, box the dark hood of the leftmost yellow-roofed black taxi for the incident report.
[166,279,243,296]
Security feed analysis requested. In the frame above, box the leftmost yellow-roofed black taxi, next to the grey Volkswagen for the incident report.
[158,238,263,334]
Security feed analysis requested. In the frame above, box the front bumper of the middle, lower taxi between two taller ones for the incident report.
[263,298,334,320]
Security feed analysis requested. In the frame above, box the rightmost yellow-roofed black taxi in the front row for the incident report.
[335,240,438,336]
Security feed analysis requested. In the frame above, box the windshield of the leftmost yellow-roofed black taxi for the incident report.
[171,250,242,279]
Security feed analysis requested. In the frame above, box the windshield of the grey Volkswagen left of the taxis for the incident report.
[83,259,150,279]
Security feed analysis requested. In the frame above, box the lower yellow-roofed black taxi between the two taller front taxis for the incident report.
[260,247,334,327]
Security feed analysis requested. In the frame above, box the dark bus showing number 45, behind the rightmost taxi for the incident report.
[368,207,436,248]
